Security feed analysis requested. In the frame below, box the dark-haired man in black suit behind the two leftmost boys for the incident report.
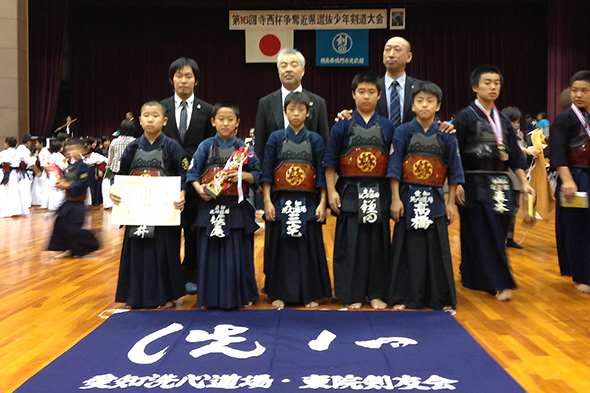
[162,57,215,294]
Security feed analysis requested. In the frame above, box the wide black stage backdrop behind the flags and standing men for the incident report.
[71,0,547,136]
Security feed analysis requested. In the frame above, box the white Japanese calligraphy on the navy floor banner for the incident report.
[79,323,459,391]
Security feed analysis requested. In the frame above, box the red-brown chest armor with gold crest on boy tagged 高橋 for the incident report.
[402,131,448,187]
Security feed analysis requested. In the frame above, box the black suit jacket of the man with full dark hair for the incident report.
[161,96,216,161]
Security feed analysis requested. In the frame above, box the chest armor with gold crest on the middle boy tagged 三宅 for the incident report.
[273,138,317,191]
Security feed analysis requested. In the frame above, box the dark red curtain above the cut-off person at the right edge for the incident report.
[547,0,590,122]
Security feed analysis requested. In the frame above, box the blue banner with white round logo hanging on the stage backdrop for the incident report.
[315,30,369,67]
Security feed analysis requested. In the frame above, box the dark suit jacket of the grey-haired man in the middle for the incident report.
[254,89,330,162]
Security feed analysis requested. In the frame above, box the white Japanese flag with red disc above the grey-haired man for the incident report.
[246,29,293,63]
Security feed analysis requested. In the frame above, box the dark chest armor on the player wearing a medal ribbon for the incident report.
[461,120,512,172]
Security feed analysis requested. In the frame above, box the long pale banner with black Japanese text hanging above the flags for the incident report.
[229,9,388,30]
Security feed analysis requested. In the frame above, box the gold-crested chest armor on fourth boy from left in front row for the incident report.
[339,121,389,177]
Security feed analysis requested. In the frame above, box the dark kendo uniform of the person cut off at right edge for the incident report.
[551,104,590,285]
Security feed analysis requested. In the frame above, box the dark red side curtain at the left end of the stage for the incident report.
[29,0,68,136]
